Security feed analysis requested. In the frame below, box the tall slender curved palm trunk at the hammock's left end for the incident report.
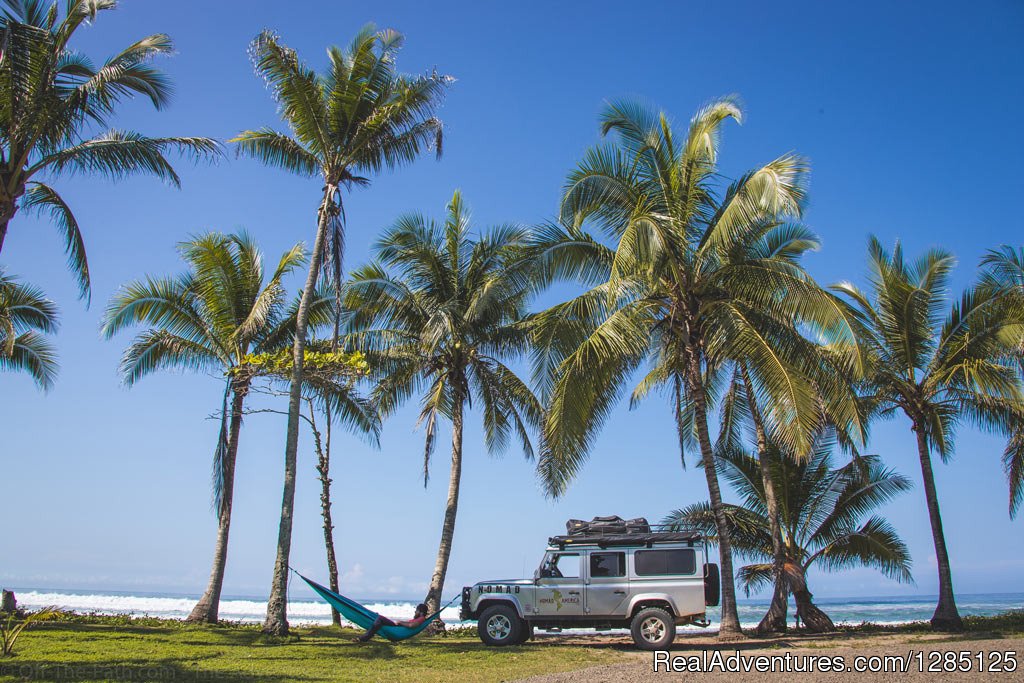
[263,184,335,636]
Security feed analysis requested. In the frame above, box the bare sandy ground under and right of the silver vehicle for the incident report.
[519,633,1024,683]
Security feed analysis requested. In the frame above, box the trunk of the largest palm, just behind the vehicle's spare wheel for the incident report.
[687,356,743,640]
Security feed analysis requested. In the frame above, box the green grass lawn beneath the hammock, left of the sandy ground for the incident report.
[0,617,622,683]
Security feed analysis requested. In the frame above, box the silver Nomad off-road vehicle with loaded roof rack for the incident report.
[461,531,719,650]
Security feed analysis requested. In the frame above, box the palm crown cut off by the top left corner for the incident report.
[0,0,219,298]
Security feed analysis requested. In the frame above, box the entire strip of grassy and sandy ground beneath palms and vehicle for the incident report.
[0,610,1024,683]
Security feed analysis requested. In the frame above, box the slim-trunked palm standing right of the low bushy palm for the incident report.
[836,237,1024,630]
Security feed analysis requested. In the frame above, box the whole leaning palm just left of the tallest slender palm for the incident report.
[102,232,313,624]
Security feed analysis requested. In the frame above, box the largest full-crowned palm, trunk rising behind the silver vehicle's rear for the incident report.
[531,98,852,639]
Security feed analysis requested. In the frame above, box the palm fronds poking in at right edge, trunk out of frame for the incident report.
[979,245,1024,517]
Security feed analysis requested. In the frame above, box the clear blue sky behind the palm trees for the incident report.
[0,0,1024,598]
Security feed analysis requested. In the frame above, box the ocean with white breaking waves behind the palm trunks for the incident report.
[13,589,1024,630]
